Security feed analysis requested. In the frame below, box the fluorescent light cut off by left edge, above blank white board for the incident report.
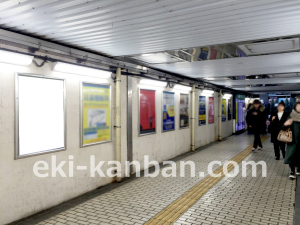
[0,50,34,66]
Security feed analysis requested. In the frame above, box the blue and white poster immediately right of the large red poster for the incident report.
[162,91,175,131]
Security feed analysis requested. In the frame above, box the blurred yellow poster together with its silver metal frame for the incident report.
[80,81,112,147]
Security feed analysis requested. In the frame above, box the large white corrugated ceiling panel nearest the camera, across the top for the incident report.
[0,0,300,56]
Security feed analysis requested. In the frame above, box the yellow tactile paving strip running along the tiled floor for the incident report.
[145,136,269,225]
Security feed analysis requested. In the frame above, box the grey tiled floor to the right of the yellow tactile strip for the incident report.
[175,140,295,225]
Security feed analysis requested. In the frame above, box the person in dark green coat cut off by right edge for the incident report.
[283,102,300,179]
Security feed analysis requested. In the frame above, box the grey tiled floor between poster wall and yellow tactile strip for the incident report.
[39,134,253,224]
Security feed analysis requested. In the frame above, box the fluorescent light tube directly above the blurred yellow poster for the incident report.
[53,62,111,78]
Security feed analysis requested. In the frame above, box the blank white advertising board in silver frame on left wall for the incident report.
[16,74,65,157]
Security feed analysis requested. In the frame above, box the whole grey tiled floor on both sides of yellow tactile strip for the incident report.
[27,134,295,225]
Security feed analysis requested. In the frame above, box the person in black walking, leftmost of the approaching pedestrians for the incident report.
[246,100,268,151]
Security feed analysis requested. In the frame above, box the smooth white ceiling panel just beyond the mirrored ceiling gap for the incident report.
[152,52,300,78]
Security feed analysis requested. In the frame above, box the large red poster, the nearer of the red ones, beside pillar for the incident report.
[140,89,156,135]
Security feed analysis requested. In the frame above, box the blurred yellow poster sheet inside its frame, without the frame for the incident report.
[82,83,111,145]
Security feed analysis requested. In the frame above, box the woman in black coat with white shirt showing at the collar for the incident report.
[268,101,290,160]
